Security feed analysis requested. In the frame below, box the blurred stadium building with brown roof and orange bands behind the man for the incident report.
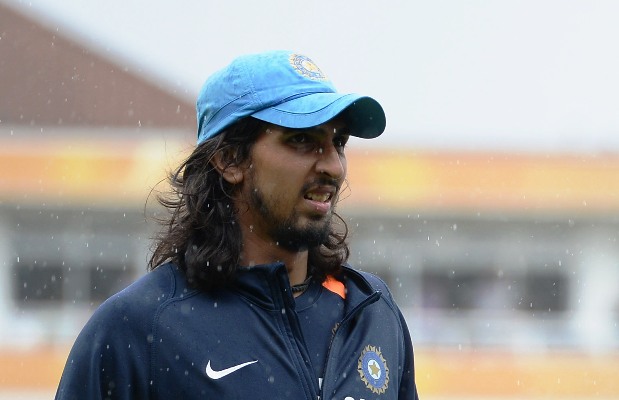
[0,3,619,400]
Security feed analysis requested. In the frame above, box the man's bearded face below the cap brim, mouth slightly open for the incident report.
[239,119,349,250]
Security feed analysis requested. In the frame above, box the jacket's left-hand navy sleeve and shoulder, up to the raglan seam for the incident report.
[56,264,183,399]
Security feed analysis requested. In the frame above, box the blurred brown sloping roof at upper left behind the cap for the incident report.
[0,4,196,130]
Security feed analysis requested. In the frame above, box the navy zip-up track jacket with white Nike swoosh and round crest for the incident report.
[56,264,418,400]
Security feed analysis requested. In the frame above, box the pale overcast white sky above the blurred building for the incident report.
[7,0,619,153]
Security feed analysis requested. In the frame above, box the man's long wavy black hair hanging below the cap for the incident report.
[148,117,350,290]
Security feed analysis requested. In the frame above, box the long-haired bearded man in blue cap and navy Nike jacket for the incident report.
[56,51,417,400]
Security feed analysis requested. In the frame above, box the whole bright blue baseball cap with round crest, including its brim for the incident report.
[196,51,386,144]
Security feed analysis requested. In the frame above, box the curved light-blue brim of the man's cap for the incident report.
[252,93,386,139]
